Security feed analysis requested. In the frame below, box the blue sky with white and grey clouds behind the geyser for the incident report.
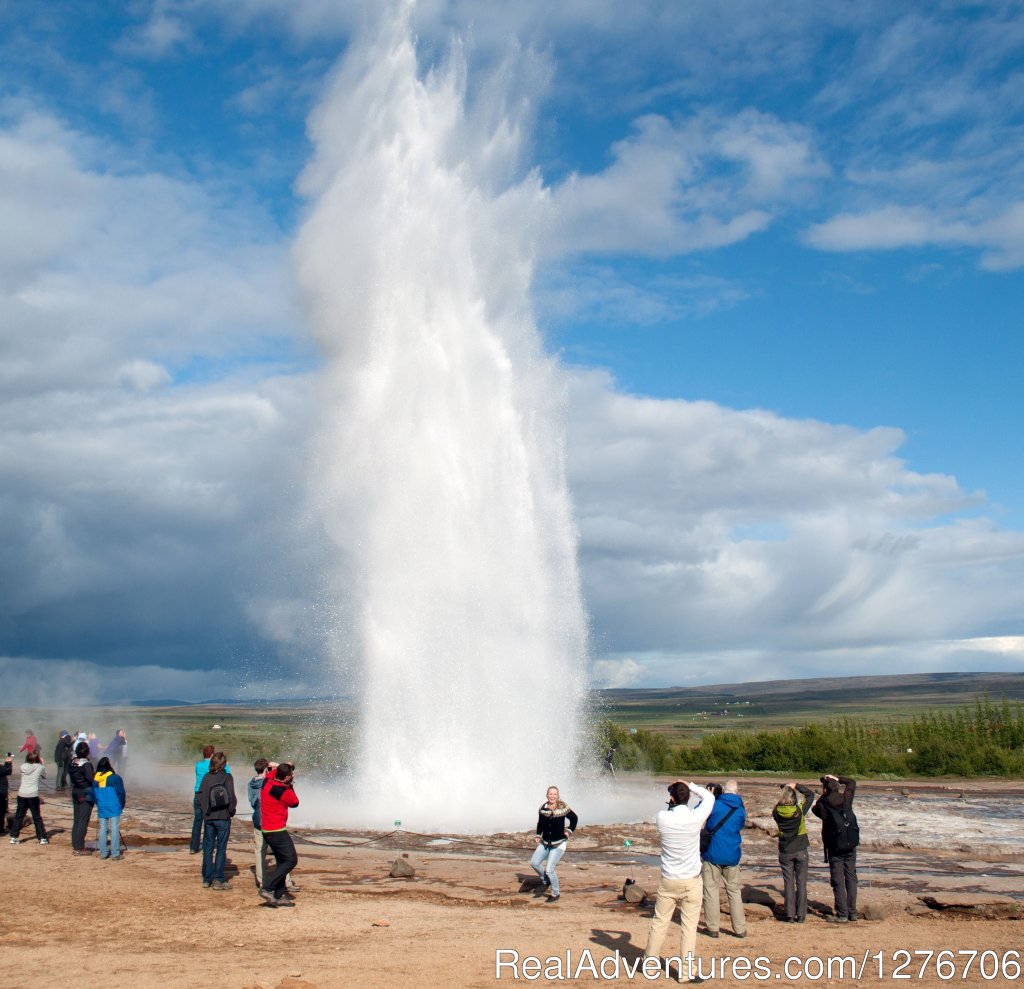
[0,0,1024,697]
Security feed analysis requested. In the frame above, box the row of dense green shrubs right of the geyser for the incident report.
[598,698,1024,776]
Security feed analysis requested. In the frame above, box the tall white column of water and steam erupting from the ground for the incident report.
[296,14,587,829]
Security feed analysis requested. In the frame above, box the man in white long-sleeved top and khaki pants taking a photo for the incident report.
[644,780,715,982]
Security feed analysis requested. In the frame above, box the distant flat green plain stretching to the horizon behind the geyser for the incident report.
[0,674,1024,770]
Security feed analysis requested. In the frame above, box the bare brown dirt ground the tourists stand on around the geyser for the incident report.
[0,783,1024,989]
